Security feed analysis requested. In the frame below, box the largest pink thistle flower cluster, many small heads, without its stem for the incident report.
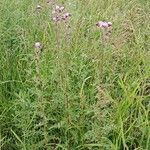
[52,5,71,22]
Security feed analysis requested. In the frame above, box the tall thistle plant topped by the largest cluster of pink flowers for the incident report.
[52,5,71,138]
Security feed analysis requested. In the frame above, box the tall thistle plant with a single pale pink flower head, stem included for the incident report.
[34,42,48,148]
